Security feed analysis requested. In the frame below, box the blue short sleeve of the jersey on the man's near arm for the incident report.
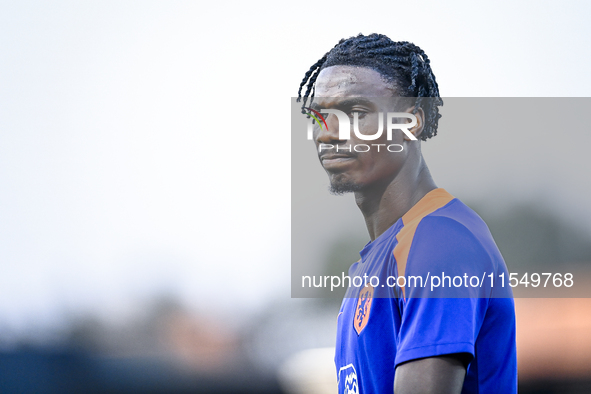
[395,216,494,365]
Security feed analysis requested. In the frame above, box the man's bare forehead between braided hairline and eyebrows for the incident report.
[314,66,394,98]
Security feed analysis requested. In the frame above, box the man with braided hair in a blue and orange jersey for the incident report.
[298,34,517,394]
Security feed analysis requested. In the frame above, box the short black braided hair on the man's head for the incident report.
[297,33,443,141]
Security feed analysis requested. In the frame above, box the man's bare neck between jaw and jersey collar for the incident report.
[355,156,437,241]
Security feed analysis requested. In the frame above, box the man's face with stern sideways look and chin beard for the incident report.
[312,66,422,194]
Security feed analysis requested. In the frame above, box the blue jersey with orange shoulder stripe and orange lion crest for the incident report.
[335,189,517,394]
